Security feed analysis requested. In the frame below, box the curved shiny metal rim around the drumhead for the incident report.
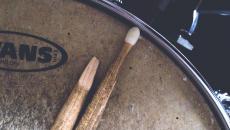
[83,0,230,129]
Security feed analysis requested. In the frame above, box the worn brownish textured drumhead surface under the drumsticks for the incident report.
[0,0,219,130]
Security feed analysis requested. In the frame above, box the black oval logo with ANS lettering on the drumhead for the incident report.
[0,31,68,72]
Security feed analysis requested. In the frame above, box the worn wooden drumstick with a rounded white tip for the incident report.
[76,27,140,130]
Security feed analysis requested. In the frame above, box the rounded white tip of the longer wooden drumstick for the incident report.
[125,27,140,45]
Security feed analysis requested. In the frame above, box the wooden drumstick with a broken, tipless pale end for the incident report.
[51,57,99,130]
